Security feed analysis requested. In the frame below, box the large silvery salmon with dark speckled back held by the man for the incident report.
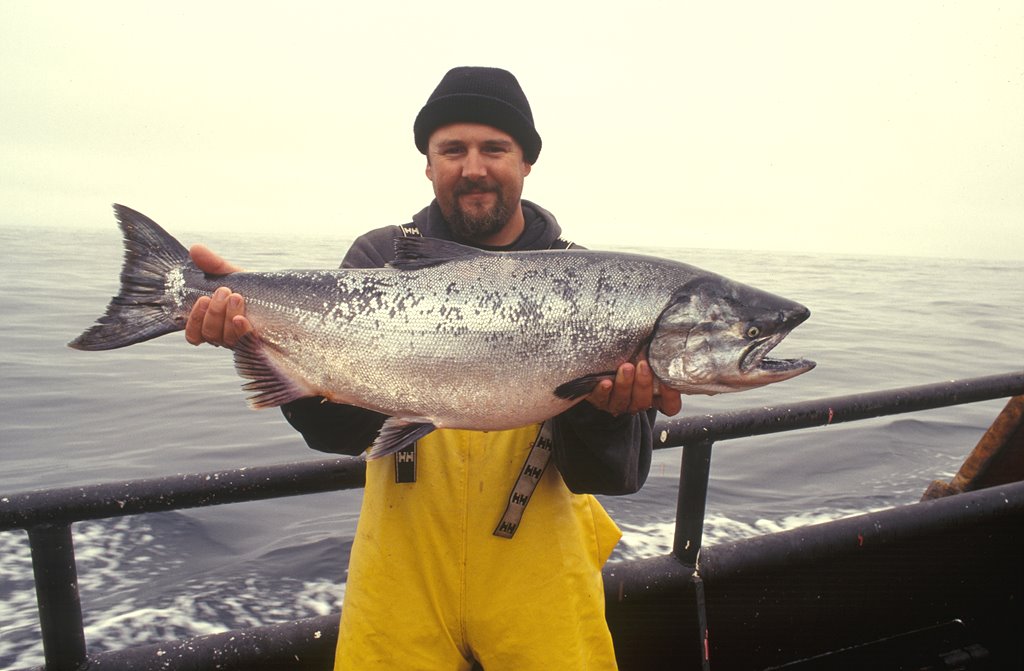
[69,205,814,456]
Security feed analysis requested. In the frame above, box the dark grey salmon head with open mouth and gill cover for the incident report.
[647,277,815,394]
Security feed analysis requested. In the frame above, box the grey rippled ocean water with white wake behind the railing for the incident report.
[0,220,1024,668]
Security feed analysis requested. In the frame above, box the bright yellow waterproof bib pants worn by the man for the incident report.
[335,425,621,671]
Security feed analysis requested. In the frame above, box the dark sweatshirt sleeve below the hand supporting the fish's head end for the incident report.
[553,402,657,495]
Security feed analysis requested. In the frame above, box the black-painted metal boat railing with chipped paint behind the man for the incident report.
[6,371,1024,671]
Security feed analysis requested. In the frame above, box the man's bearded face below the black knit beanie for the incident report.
[427,123,530,244]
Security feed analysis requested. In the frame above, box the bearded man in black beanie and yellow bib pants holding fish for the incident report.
[185,68,680,671]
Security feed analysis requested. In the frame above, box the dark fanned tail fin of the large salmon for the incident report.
[68,205,199,350]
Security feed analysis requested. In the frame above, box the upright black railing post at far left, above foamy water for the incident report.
[28,523,85,671]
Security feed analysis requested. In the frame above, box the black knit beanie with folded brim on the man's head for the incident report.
[413,67,541,165]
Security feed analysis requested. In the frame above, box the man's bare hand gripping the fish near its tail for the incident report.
[185,245,253,347]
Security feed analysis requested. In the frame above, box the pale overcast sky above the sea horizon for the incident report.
[0,0,1024,260]
